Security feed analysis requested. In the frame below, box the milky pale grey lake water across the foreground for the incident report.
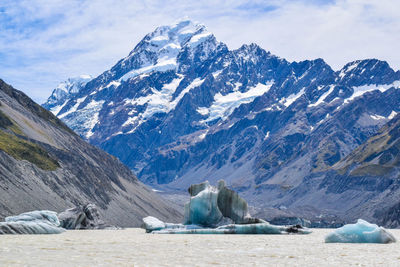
[0,228,400,266]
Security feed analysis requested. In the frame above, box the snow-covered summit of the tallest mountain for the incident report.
[111,19,218,81]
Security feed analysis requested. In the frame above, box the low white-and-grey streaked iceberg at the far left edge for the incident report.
[0,210,65,234]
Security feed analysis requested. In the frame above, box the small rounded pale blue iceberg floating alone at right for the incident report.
[325,219,396,244]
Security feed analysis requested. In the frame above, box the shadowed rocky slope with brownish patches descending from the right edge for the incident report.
[250,115,400,227]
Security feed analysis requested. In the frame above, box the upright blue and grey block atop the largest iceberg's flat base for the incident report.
[184,180,262,227]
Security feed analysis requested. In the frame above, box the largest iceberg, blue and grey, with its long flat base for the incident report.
[143,180,310,234]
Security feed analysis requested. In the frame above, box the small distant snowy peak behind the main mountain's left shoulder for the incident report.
[43,75,93,115]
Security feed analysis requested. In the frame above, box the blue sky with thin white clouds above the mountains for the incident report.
[0,0,400,103]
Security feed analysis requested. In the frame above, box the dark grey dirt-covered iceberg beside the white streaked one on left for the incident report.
[58,204,116,230]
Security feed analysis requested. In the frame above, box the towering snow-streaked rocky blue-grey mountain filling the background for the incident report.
[43,20,400,224]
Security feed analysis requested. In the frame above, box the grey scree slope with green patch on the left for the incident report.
[0,80,181,226]
